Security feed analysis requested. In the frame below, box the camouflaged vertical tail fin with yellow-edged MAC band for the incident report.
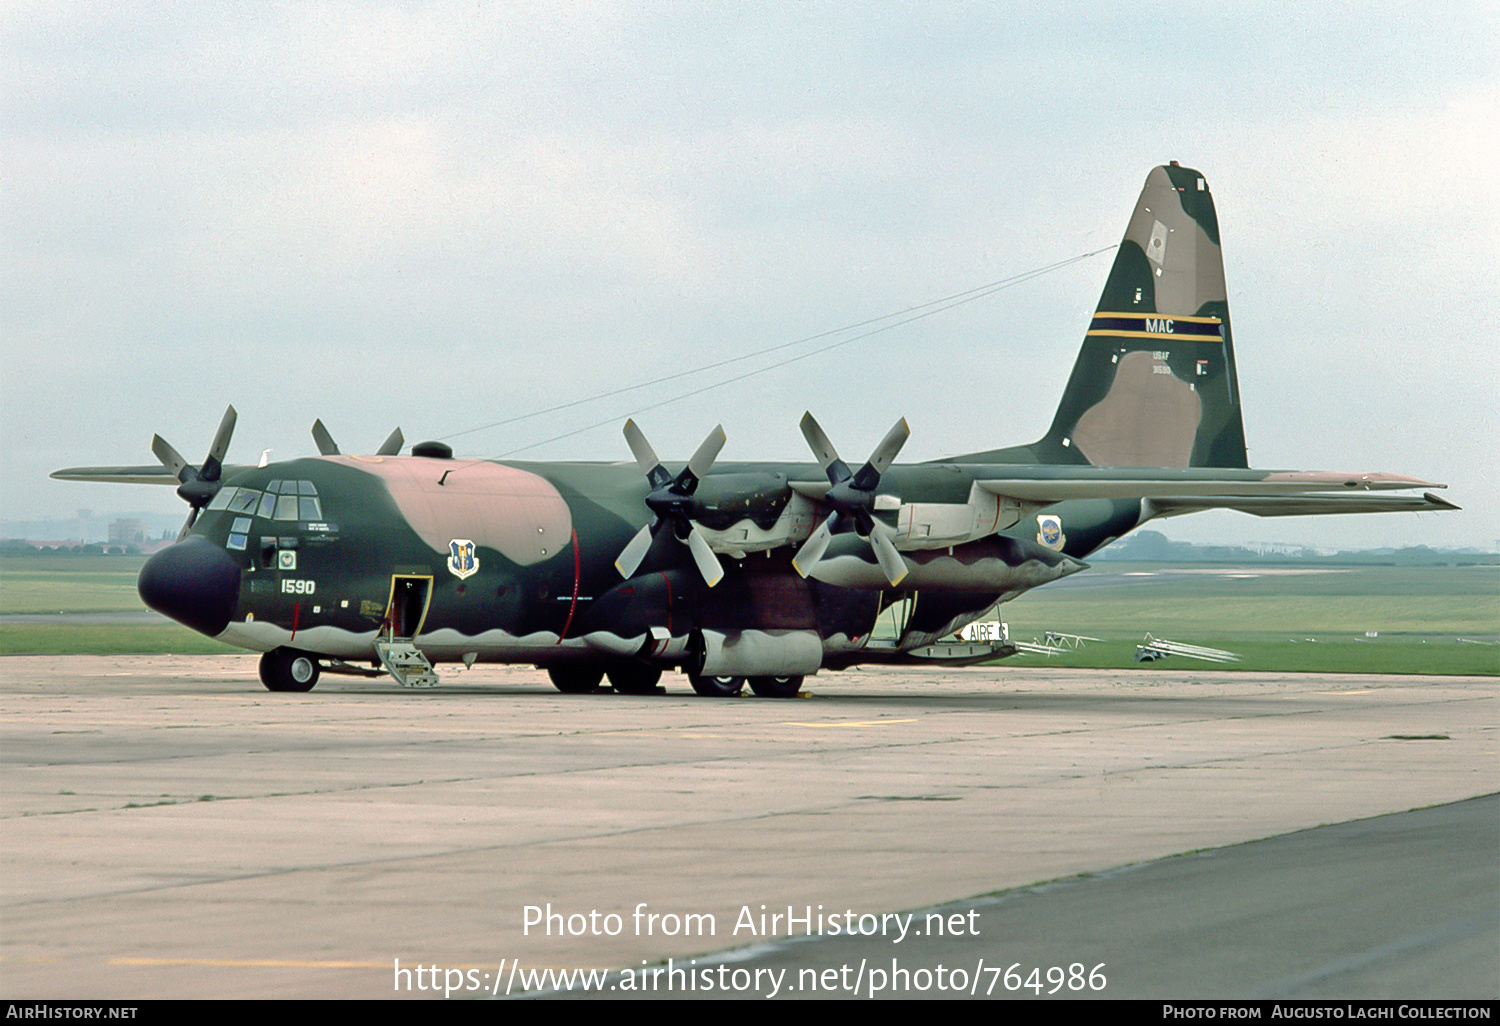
[1029,164,1248,467]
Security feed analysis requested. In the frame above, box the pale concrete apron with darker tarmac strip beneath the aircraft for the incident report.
[0,656,1500,999]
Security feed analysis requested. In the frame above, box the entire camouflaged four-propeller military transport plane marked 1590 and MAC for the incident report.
[53,164,1457,696]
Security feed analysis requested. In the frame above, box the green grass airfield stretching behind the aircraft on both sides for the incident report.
[0,555,1500,675]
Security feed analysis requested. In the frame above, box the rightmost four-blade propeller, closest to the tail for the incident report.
[792,413,912,585]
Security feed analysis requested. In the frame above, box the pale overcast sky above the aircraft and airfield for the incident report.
[0,0,1500,548]
